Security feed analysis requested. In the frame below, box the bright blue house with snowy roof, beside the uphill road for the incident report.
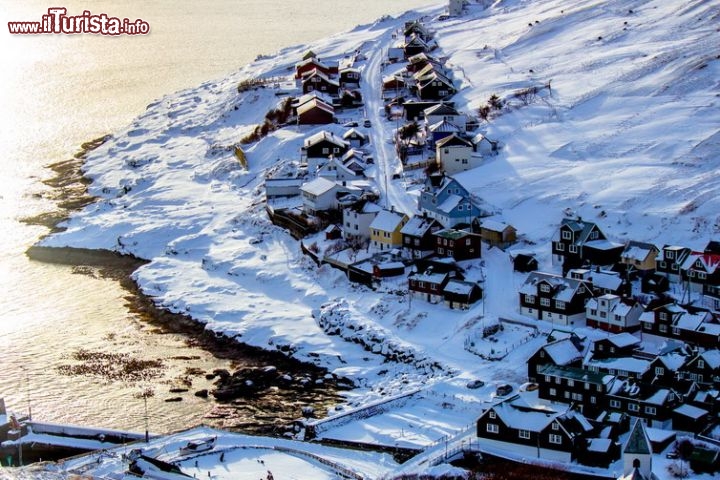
[418,174,480,228]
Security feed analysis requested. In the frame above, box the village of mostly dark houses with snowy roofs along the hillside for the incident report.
[249,10,720,478]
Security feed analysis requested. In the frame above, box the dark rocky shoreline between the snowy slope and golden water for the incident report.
[21,135,353,435]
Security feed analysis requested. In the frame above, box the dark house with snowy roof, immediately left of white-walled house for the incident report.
[519,272,592,327]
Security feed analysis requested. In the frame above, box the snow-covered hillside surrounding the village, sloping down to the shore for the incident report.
[38,0,720,478]
